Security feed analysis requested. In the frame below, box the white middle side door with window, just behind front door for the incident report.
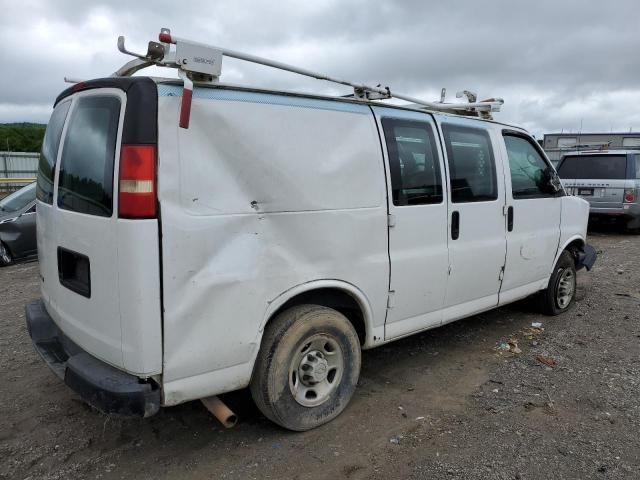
[437,116,506,322]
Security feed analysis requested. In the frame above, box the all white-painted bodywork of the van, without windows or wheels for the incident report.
[38,81,588,406]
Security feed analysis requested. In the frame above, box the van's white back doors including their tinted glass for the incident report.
[37,79,162,376]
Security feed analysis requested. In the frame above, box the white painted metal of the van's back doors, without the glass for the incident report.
[37,88,162,377]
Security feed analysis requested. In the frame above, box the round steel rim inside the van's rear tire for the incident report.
[289,334,344,407]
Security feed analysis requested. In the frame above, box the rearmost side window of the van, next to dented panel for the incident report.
[382,118,442,206]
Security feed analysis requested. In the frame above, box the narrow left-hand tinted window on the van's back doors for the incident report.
[36,101,71,204]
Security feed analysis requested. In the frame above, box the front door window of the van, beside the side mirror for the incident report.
[503,134,554,199]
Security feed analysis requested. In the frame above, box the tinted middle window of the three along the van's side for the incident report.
[442,124,498,203]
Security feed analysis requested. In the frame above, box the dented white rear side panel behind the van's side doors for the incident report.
[158,85,389,405]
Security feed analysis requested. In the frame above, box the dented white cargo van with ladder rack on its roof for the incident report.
[26,30,595,430]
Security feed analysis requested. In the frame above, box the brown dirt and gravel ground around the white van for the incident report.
[0,231,640,480]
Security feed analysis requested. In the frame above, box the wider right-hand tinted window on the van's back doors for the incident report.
[58,96,120,217]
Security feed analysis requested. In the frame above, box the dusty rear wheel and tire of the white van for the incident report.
[251,305,361,431]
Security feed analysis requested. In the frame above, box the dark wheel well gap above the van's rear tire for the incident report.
[267,288,367,345]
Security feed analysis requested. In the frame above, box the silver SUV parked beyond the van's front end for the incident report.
[558,150,640,232]
